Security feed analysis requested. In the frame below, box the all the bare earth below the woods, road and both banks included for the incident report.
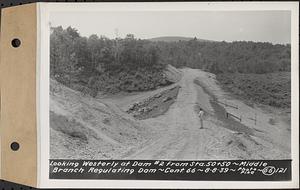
[50,68,290,160]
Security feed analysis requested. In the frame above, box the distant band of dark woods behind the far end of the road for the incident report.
[157,39,291,74]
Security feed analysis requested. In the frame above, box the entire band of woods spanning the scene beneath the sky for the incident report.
[50,27,291,106]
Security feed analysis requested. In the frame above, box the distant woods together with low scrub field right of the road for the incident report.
[157,39,291,108]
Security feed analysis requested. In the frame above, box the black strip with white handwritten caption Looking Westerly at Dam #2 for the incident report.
[49,160,290,180]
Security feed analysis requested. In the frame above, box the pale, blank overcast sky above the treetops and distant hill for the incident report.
[50,11,291,44]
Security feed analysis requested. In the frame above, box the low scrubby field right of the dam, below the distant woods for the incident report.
[217,72,291,108]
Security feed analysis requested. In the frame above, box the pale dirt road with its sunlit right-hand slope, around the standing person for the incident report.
[120,68,290,160]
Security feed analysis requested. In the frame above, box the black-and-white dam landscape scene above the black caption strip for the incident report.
[49,8,291,160]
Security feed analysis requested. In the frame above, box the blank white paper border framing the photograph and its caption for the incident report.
[36,2,299,189]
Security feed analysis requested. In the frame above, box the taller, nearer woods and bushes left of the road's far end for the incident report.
[50,27,170,96]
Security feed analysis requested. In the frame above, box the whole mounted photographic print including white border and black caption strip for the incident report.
[33,2,299,188]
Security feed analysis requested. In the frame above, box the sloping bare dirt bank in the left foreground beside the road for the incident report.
[50,80,147,159]
